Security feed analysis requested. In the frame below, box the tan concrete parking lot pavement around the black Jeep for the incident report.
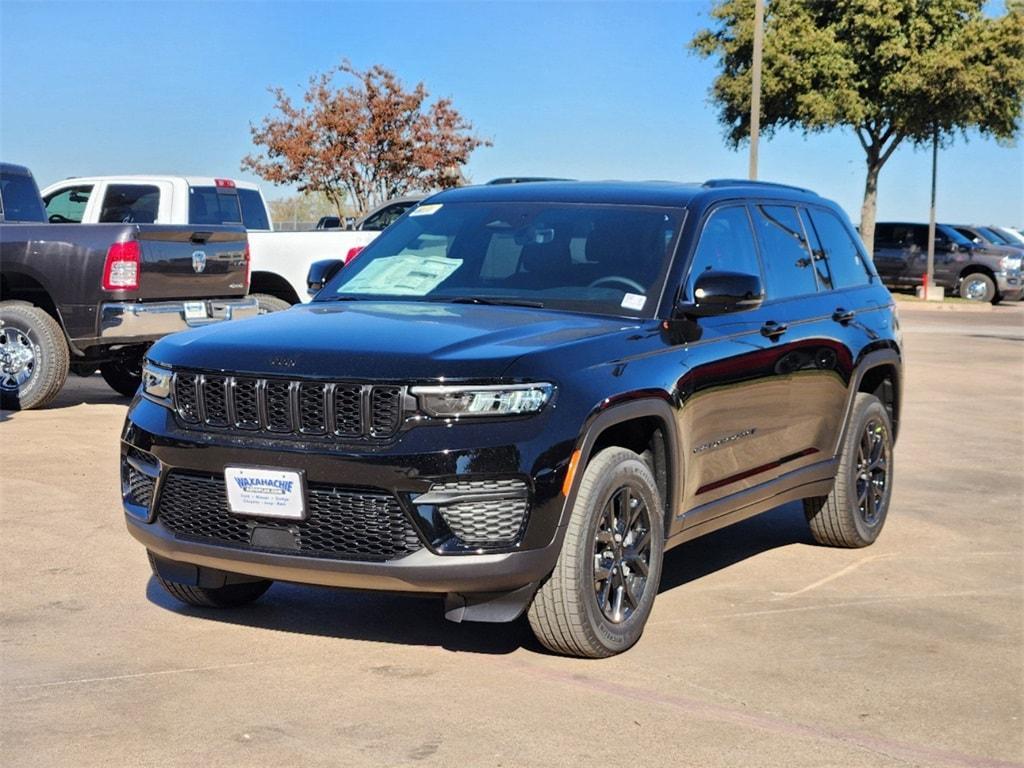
[0,304,1024,768]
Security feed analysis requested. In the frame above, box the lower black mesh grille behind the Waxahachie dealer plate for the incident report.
[157,472,422,561]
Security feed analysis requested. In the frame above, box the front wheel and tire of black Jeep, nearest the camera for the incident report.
[527,447,665,658]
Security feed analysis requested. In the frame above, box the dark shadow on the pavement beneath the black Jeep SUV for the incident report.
[146,503,813,654]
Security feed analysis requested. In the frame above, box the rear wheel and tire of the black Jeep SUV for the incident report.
[804,392,893,548]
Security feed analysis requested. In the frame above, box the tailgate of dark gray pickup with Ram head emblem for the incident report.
[135,224,249,301]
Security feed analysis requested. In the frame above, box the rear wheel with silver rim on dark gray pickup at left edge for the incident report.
[0,301,71,411]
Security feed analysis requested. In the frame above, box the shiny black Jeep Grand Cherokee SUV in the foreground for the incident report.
[121,181,902,656]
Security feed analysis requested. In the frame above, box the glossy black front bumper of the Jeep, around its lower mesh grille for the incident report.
[122,398,572,595]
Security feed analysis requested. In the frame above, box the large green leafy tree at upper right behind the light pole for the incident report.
[690,0,1024,249]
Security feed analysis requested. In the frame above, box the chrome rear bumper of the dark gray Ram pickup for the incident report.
[99,296,259,343]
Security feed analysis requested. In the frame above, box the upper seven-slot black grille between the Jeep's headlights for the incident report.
[174,373,404,439]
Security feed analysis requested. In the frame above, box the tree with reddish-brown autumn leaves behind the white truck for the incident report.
[242,60,490,218]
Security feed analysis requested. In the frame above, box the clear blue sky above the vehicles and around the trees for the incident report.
[0,0,1024,224]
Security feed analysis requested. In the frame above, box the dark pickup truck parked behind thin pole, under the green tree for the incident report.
[874,221,1024,304]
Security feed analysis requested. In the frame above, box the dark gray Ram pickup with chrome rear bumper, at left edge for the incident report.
[0,163,257,410]
